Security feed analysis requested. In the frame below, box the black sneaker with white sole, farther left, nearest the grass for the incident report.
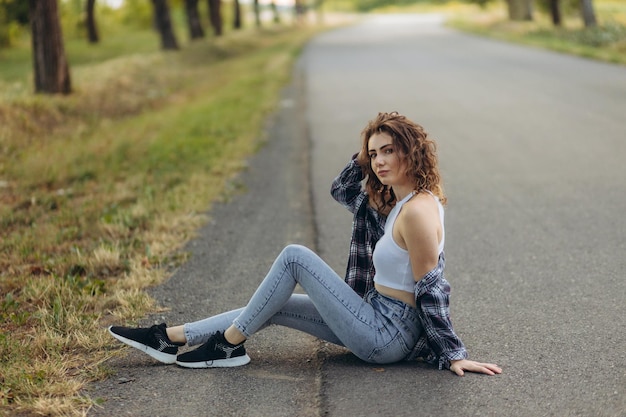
[109,323,184,364]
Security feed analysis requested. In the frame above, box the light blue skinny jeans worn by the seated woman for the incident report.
[184,245,423,364]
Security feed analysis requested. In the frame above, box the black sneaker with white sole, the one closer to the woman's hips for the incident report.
[176,332,250,368]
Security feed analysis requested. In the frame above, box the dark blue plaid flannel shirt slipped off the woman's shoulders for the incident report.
[331,154,468,369]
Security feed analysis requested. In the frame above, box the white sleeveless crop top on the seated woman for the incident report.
[372,191,445,292]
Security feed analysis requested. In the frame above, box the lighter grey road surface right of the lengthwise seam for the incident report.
[304,16,626,416]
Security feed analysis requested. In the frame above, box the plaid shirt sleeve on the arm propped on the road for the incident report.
[415,253,468,369]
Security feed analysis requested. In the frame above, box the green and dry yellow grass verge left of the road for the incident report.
[0,15,317,416]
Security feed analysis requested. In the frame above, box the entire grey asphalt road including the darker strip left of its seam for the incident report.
[90,15,626,417]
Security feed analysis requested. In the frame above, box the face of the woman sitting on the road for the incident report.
[367,132,409,186]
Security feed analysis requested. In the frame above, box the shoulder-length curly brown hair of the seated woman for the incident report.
[357,112,447,213]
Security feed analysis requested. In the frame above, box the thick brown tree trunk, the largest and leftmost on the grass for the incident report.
[29,0,72,94]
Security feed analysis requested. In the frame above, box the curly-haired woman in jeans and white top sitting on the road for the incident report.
[109,112,501,375]
